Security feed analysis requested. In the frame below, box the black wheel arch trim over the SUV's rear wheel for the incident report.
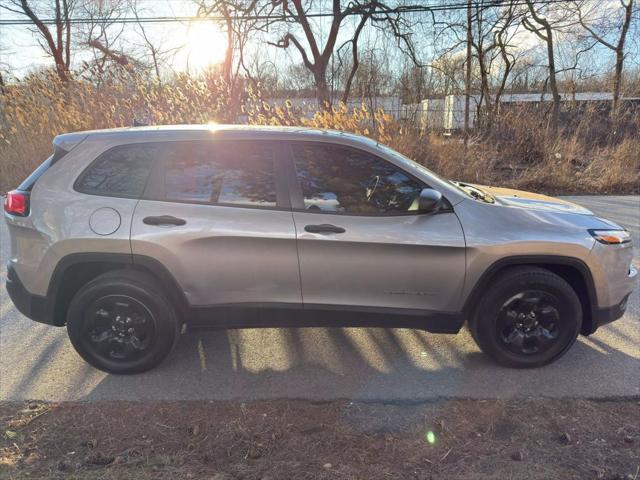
[47,253,189,326]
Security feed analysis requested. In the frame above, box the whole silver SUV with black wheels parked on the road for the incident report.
[4,126,637,373]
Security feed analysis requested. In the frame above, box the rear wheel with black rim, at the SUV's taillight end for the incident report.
[67,270,180,374]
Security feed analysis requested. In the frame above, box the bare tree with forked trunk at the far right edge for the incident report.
[576,0,634,119]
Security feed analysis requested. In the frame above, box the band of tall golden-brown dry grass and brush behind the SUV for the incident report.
[0,73,640,193]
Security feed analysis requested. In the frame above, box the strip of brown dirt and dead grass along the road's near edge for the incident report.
[0,399,640,480]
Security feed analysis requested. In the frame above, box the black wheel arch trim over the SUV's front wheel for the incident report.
[463,255,597,335]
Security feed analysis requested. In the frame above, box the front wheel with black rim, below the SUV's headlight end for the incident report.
[469,267,582,368]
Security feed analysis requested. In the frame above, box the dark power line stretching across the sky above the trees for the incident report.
[0,0,572,26]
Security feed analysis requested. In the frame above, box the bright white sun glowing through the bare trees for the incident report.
[185,22,227,71]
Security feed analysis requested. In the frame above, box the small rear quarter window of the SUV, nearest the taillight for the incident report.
[76,144,154,198]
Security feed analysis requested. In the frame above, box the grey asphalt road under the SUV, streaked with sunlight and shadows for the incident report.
[0,196,640,401]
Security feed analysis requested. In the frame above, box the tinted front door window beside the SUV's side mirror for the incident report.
[293,144,423,214]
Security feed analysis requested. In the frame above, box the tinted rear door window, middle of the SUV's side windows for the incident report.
[164,143,276,207]
